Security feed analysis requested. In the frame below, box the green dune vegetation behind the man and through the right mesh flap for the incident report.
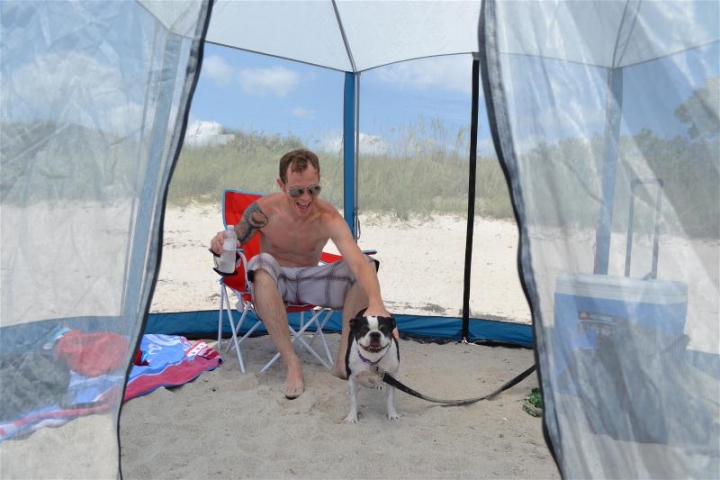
[169,120,720,238]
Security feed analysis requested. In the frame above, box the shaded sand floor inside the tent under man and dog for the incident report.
[120,334,559,480]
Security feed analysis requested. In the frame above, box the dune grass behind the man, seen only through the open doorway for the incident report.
[168,124,512,219]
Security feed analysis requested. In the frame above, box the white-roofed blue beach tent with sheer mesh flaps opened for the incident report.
[0,0,720,478]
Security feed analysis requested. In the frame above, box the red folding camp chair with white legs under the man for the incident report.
[216,190,342,373]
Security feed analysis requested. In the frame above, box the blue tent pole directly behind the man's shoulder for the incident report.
[343,72,359,240]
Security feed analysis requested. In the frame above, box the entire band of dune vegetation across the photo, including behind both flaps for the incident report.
[5,116,720,239]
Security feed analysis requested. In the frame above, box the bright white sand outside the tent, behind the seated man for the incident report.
[151,205,530,324]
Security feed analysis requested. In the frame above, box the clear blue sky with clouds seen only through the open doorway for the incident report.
[189,44,489,154]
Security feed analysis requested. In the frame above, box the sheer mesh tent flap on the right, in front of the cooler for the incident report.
[480,1,720,478]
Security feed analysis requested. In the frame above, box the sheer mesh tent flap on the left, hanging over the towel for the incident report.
[0,1,211,478]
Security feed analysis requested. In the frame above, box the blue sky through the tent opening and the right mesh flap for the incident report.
[189,40,720,155]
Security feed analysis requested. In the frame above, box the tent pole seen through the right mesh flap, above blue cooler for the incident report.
[594,68,623,275]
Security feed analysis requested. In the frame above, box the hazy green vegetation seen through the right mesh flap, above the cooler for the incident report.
[520,130,720,238]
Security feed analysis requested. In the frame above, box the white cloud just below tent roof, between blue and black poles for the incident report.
[377,55,472,94]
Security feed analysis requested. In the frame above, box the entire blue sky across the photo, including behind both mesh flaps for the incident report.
[0,19,720,155]
